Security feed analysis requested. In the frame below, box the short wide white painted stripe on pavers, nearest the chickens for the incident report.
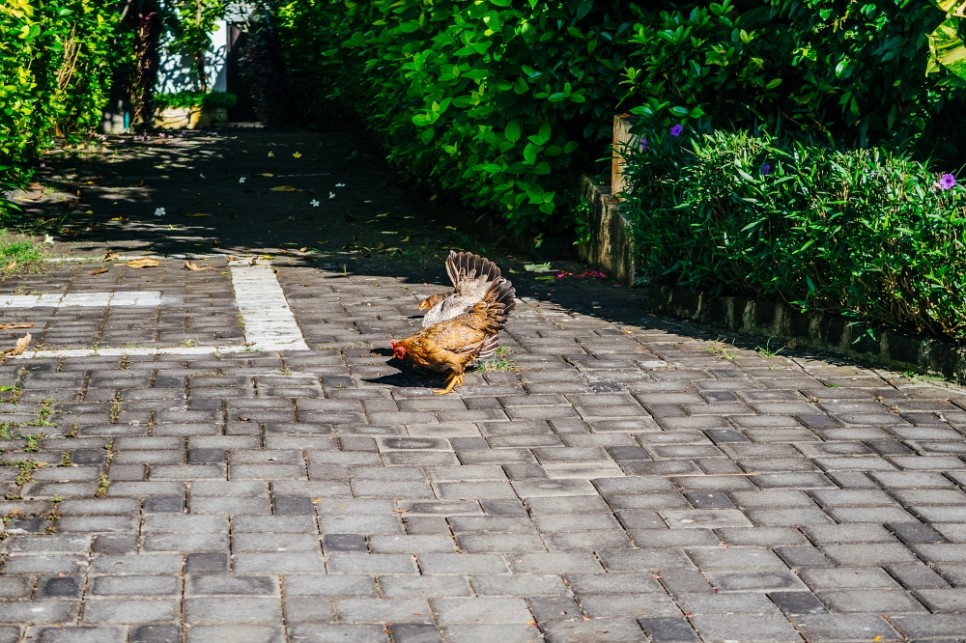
[228,260,309,351]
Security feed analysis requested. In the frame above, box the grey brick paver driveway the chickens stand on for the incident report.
[0,132,966,643]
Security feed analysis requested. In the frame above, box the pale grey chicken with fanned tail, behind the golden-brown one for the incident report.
[419,250,506,328]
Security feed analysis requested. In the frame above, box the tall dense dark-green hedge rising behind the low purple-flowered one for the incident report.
[273,0,966,232]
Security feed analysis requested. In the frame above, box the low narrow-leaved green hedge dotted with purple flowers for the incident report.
[624,128,966,341]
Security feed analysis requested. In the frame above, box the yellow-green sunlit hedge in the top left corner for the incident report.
[0,0,119,218]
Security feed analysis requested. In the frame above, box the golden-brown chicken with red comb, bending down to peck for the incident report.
[392,277,516,394]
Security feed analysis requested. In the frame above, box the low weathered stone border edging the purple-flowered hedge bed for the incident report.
[578,176,966,384]
